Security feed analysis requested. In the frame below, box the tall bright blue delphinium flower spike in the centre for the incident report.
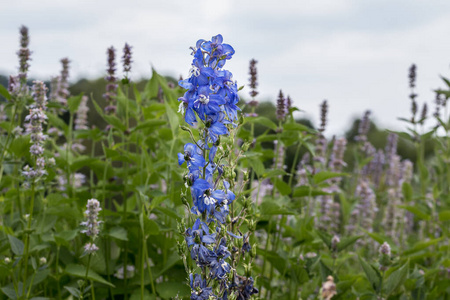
[178,35,256,299]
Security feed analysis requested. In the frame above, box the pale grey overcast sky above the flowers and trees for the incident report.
[0,0,450,135]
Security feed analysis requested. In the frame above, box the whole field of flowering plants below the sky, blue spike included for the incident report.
[0,26,450,300]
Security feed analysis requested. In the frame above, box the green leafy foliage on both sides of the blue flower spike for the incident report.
[0,38,450,299]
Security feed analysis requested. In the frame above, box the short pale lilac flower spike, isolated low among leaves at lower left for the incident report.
[81,199,102,254]
